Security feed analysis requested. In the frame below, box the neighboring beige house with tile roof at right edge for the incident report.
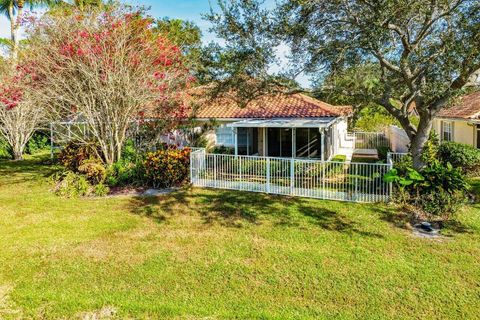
[433,92,480,148]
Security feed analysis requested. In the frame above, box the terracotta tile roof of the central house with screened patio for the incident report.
[191,94,352,119]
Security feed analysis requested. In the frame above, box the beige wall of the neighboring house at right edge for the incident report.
[433,118,477,146]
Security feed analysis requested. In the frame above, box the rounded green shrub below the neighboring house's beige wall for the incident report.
[438,142,480,174]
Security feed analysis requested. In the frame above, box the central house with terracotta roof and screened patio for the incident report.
[188,94,352,160]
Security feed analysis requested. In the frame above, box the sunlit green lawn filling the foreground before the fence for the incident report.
[0,156,480,319]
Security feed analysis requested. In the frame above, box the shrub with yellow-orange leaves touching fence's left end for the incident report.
[145,149,190,188]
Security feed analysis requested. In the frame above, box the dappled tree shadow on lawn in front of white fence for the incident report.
[125,188,382,238]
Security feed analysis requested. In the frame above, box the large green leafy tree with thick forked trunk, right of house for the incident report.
[204,0,480,169]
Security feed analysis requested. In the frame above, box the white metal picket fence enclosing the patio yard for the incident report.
[190,150,391,202]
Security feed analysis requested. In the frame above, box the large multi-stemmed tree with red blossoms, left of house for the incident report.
[23,6,193,164]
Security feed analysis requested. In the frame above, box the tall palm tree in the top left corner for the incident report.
[0,0,60,59]
